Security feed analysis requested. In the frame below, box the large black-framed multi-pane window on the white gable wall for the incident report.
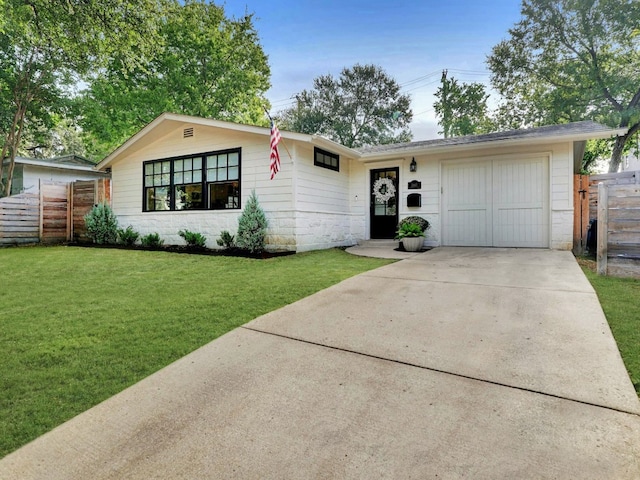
[143,149,240,212]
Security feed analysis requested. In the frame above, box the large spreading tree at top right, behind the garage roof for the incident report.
[488,0,640,172]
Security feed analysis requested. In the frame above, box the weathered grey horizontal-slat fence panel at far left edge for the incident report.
[0,193,40,245]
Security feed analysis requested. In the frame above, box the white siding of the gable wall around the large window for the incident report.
[112,123,295,250]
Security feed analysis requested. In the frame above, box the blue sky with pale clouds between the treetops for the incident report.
[225,0,520,140]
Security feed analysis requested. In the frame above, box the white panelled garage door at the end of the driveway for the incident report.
[442,157,549,247]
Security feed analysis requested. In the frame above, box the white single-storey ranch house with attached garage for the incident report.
[97,113,622,252]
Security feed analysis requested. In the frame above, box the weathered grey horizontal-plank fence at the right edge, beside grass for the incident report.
[596,183,640,278]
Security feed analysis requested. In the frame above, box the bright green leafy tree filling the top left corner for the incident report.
[0,0,172,196]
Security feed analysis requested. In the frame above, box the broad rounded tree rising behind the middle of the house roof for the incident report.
[278,65,413,148]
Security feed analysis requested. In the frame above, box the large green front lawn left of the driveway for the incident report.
[0,247,390,457]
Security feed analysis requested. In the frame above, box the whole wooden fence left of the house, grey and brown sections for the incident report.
[0,179,111,245]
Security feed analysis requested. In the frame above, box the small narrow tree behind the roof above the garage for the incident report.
[433,70,495,138]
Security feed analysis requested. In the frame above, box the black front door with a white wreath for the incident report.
[371,168,399,238]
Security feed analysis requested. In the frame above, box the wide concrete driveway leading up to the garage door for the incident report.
[0,248,640,480]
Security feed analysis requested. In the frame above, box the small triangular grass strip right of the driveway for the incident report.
[578,259,640,395]
